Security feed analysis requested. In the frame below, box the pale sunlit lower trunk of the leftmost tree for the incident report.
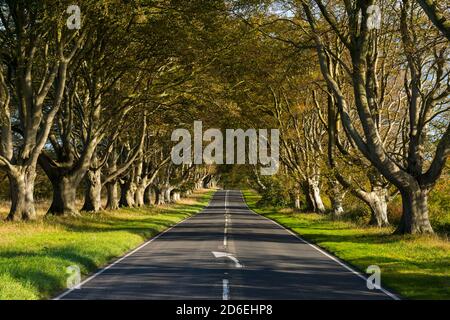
[6,167,36,221]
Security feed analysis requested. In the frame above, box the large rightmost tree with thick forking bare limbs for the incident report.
[301,0,450,233]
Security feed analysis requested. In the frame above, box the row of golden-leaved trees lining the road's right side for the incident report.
[223,0,450,233]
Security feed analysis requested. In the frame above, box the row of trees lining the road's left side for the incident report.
[0,0,229,220]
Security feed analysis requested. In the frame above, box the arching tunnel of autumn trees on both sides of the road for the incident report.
[0,0,450,234]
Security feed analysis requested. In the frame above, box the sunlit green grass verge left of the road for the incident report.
[0,191,213,300]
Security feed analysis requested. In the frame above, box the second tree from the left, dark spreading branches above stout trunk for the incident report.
[39,13,145,215]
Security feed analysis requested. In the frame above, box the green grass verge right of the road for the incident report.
[244,190,450,299]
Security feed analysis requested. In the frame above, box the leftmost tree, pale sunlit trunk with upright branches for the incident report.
[0,0,85,220]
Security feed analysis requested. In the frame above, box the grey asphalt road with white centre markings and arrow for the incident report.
[58,190,393,300]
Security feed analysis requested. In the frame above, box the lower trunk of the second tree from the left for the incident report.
[47,176,79,216]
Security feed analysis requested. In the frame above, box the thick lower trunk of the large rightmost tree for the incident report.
[395,186,433,234]
